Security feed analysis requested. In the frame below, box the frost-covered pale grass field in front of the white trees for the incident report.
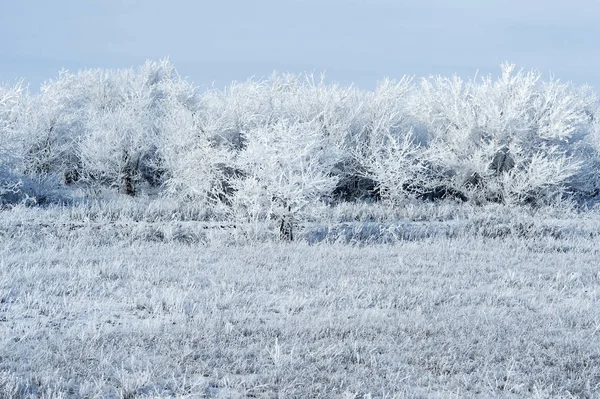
[0,207,600,398]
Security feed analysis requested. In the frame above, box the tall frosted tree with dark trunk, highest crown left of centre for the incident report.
[80,61,191,195]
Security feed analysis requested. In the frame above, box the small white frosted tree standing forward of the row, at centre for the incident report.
[230,120,339,239]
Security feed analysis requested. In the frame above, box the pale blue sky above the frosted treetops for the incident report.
[0,0,600,91]
